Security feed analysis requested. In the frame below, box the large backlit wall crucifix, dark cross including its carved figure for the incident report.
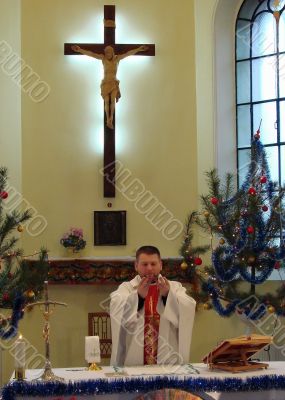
[64,6,155,197]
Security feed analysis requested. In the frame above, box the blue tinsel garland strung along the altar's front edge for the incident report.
[2,375,285,400]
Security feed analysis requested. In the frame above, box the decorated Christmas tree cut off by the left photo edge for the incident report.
[0,167,48,339]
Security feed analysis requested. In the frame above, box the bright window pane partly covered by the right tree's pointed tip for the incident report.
[253,101,277,144]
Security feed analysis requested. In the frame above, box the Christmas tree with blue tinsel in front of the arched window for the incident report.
[181,131,285,320]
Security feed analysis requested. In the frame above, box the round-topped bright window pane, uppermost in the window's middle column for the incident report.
[252,12,276,57]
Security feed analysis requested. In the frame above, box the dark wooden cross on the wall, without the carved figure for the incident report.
[64,6,155,197]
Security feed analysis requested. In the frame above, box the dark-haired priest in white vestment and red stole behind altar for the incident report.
[110,246,196,366]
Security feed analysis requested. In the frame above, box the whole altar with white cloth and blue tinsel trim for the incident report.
[2,362,285,400]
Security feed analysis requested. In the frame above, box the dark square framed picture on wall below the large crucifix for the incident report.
[94,211,127,246]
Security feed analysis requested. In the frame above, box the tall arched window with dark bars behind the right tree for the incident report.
[236,0,285,185]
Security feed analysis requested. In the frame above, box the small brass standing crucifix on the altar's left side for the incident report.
[25,281,67,382]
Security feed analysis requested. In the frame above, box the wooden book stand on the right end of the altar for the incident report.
[203,334,273,373]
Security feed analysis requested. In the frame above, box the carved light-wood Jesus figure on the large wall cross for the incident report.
[71,45,148,129]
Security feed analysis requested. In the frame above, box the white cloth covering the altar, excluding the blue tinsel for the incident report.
[3,362,285,400]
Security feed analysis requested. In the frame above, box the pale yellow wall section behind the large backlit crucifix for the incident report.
[22,0,197,256]
